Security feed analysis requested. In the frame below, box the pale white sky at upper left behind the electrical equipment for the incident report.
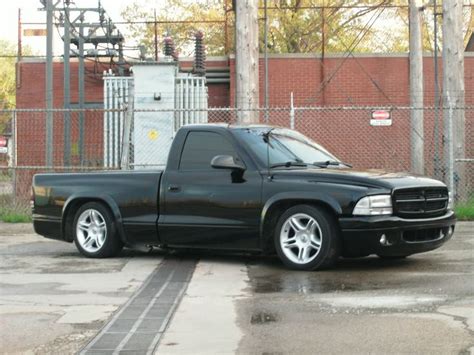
[0,0,166,55]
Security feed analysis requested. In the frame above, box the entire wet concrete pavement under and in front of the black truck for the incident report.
[0,223,474,354]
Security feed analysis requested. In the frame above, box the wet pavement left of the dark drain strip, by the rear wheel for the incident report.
[0,227,163,354]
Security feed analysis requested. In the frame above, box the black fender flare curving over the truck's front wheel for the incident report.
[260,191,342,239]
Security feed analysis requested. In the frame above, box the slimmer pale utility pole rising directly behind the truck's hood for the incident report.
[409,0,424,174]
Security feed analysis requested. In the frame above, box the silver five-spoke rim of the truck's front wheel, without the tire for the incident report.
[280,213,323,264]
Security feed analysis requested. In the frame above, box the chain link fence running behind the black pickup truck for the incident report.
[0,107,474,213]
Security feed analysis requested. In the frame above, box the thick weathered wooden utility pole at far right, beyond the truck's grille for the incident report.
[443,0,467,199]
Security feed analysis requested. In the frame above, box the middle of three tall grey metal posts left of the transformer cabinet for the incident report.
[63,2,71,166]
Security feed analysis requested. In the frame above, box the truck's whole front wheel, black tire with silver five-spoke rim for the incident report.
[274,205,340,270]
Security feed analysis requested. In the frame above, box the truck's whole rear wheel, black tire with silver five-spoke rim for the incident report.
[72,202,123,258]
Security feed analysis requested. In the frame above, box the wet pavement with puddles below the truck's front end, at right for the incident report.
[237,223,474,354]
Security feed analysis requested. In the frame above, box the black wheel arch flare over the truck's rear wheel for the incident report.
[61,194,126,243]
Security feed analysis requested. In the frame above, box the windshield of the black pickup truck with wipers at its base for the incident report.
[236,127,339,167]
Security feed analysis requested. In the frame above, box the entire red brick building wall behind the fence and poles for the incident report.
[17,55,474,175]
